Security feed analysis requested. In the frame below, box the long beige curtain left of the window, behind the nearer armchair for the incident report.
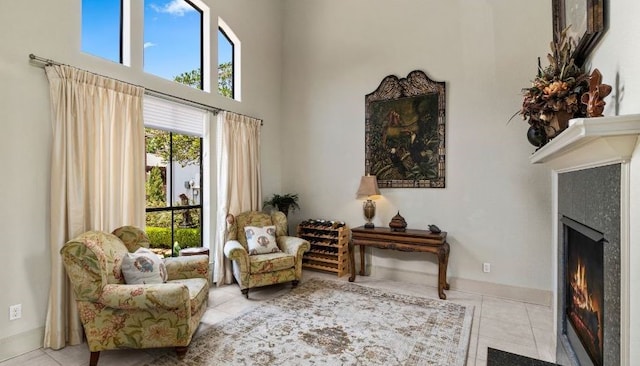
[44,65,145,349]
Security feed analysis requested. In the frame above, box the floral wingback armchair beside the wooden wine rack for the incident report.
[224,211,310,298]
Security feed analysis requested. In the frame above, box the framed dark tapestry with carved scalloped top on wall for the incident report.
[365,70,446,188]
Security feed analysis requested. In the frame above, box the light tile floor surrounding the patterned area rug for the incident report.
[0,271,555,366]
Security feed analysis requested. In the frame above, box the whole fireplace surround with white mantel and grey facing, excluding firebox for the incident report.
[530,114,640,366]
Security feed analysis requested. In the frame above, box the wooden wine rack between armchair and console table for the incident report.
[298,220,351,277]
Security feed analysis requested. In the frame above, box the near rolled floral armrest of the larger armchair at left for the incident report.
[98,283,191,314]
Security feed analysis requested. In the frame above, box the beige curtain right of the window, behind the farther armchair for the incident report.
[213,112,262,286]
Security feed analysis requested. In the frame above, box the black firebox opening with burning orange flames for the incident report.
[561,217,605,366]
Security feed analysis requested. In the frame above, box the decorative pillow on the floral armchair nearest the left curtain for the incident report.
[122,248,167,285]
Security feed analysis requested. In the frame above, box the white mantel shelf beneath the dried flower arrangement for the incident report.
[530,114,640,170]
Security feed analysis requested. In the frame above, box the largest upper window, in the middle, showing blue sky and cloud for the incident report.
[144,0,203,89]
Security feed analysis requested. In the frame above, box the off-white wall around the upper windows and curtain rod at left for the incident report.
[0,0,282,360]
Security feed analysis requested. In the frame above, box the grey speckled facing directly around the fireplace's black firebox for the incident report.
[556,163,621,366]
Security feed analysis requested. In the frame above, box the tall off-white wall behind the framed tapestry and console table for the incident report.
[282,0,552,299]
